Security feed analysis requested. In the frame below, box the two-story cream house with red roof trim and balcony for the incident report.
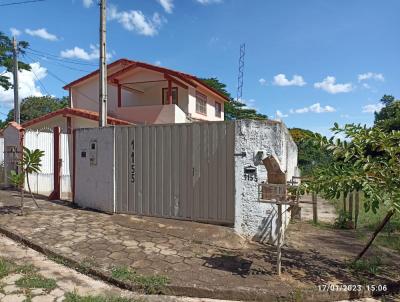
[22,59,229,133]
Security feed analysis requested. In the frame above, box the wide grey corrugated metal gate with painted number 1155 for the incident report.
[115,123,234,225]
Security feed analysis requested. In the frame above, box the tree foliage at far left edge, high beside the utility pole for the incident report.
[0,32,31,90]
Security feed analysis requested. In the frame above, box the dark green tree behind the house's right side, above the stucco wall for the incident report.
[201,78,268,120]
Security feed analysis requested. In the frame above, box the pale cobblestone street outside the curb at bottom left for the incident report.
[0,235,241,302]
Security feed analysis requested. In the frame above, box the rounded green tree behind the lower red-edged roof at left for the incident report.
[0,96,68,127]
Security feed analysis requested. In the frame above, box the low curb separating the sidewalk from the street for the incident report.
[0,225,400,302]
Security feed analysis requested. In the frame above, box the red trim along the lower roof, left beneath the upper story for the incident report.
[22,108,134,128]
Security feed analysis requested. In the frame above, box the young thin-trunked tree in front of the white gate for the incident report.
[9,147,44,215]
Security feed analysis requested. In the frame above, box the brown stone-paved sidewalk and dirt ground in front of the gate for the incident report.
[0,191,400,301]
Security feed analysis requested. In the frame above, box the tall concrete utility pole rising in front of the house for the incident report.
[99,0,107,127]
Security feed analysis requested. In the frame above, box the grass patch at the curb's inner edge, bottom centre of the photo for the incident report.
[111,266,169,295]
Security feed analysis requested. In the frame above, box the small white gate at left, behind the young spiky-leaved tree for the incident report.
[24,130,54,195]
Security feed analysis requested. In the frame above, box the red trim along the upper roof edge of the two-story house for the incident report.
[63,59,230,102]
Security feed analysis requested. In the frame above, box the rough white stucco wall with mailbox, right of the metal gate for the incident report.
[235,121,297,243]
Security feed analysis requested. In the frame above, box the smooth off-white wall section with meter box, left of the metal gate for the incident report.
[75,127,115,212]
